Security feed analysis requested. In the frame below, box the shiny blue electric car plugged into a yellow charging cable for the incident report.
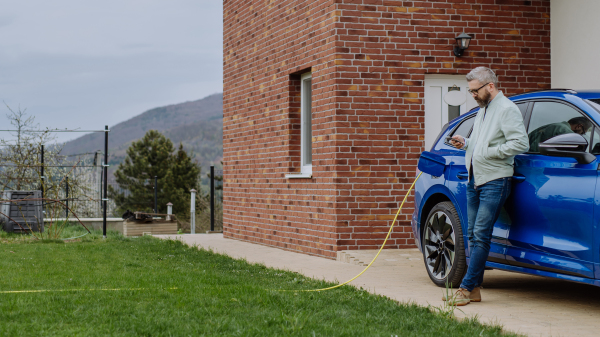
[412,89,600,286]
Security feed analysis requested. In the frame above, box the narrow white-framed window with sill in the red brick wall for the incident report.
[286,72,312,178]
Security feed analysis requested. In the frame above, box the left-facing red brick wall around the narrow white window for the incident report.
[223,0,337,257]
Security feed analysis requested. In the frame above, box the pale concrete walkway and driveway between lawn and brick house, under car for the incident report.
[157,234,600,336]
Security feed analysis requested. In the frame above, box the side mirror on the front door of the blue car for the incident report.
[540,133,596,164]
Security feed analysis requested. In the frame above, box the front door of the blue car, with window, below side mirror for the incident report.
[505,101,598,278]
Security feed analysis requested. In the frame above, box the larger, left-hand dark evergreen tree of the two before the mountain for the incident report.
[109,130,174,213]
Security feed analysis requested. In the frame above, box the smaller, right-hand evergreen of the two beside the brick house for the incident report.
[165,143,200,218]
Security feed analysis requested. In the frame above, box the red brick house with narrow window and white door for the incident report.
[223,0,551,258]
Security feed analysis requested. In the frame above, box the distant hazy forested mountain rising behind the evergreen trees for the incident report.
[61,93,223,176]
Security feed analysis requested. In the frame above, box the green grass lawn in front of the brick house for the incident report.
[0,227,516,336]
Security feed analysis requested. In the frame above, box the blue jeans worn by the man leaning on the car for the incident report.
[460,177,512,291]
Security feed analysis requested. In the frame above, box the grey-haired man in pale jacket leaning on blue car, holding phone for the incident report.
[443,67,529,306]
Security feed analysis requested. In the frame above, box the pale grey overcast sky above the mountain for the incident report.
[0,0,223,141]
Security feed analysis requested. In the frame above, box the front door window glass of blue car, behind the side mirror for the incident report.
[527,102,593,153]
